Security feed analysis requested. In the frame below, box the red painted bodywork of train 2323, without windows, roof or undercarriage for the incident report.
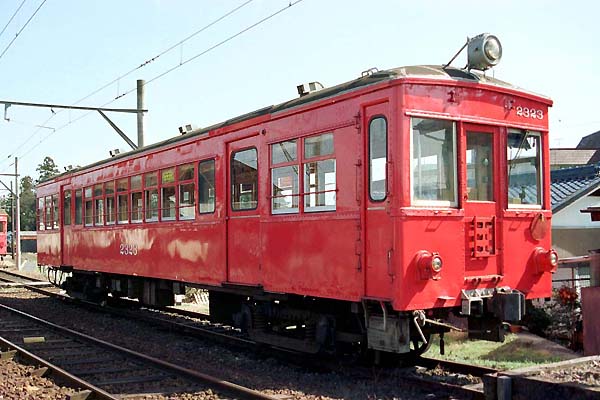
[38,68,551,310]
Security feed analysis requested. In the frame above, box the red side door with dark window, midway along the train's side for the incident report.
[227,138,262,285]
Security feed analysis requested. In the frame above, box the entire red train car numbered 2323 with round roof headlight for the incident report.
[37,35,557,355]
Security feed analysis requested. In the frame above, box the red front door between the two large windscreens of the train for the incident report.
[463,124,502,280]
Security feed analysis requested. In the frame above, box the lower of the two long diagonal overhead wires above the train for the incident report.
[4,0,304,165]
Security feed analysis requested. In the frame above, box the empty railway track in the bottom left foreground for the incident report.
[0,304,284,400]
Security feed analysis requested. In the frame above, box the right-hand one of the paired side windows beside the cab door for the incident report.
[304,133,336,212]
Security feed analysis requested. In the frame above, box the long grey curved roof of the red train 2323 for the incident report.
[41,65,550,183]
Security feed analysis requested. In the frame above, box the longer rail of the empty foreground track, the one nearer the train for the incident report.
[0,304,280,400]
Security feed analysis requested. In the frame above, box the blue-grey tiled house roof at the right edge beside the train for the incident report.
[550,164,600,213]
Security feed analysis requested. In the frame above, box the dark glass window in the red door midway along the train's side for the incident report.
[231,148,258,211]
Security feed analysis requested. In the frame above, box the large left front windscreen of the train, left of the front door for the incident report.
[411,118,457,206]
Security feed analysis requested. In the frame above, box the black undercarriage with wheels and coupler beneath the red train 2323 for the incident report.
[56,268,524,363]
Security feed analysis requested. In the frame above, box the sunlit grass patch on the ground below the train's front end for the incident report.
[425,333,563,369]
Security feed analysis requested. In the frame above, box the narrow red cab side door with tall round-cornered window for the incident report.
[363,102,394,297]
